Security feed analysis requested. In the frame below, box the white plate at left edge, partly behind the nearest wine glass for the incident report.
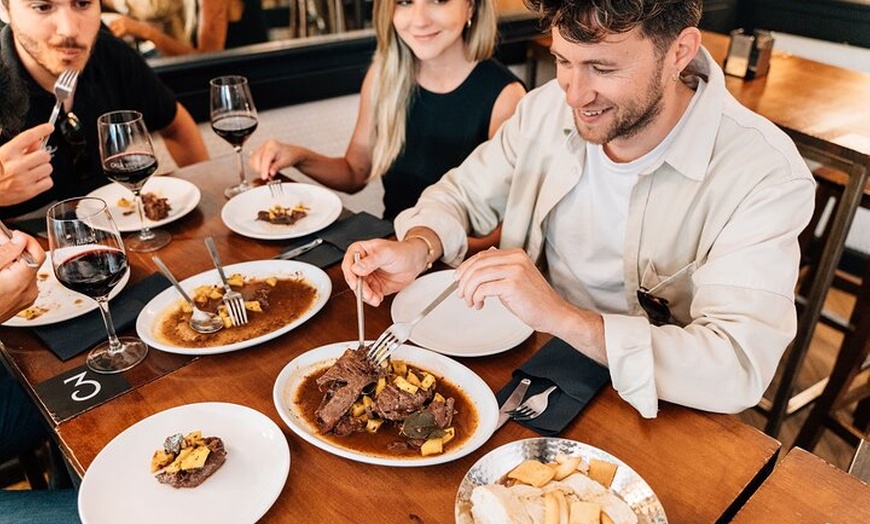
[3,253,130,327]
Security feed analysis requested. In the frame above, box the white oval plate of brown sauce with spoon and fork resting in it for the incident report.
[136,260,332,355]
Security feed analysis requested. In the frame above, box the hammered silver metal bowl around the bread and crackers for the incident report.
[454,437,668,524]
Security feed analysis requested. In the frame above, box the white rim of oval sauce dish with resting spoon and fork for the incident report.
[136,260,332,355]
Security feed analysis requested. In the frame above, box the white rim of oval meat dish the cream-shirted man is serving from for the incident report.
[272,341,498,467]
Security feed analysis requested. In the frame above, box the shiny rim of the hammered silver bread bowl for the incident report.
[454,437,668,524]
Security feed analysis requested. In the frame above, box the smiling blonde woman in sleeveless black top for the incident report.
[250,0,525,251]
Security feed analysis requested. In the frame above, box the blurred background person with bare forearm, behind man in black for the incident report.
[103,0,268,56]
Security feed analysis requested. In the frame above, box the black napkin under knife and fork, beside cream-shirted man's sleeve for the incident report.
[496,338,610,437]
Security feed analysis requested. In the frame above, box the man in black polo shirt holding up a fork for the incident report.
[0,0,208,218]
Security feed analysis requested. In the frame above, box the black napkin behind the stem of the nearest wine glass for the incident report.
[33,273,170,361]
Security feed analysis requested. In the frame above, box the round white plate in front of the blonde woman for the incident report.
[221,183,341,240]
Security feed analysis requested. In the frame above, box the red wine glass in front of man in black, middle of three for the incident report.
[97,111,172,253]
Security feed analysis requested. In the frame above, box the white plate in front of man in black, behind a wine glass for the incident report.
[87,175,202,233]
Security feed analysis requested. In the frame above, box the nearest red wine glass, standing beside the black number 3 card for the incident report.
[46,197,148,373]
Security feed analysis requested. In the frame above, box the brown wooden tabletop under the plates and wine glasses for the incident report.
[0,157,780,524]
